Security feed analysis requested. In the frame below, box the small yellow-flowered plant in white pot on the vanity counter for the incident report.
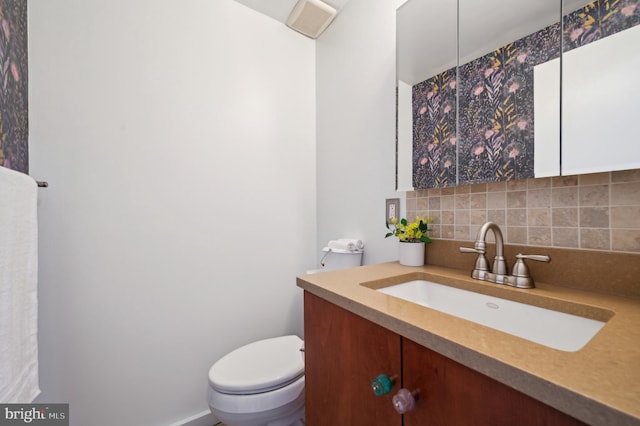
[385,216,433,266]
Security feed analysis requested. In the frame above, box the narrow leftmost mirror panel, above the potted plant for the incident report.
[396,0,458,191]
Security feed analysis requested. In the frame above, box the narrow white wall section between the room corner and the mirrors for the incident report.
[316,0,404,264]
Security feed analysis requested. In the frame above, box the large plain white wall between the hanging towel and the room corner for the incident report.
[29,0,318,426]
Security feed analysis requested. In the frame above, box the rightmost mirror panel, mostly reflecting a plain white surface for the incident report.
[562,0,640,175]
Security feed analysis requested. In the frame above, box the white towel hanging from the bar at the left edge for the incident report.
[0,167,40,403]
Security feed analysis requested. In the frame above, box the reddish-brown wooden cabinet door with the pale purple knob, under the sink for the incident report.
[403,339,584,426]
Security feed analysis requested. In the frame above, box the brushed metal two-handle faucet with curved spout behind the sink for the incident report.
[460,222,551,288]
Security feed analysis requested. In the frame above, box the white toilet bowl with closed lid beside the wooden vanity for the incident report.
[208,336,304,426]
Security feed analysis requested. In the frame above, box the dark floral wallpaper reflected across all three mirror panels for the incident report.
[412,0,640,189]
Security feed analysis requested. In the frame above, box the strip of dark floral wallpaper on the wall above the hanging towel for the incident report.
[0,0,29,173]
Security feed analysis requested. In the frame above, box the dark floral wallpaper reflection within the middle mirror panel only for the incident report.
[458,24,560,184]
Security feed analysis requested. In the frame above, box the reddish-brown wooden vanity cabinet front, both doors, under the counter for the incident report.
[304,292,585,426]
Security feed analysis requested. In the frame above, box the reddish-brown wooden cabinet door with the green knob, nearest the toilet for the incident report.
[304,292,402,426]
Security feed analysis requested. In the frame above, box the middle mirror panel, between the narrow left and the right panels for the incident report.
[458,0,561,184]
